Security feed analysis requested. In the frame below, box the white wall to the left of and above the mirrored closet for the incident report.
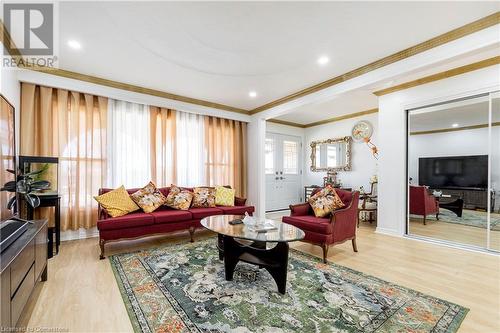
[377,65,500,235]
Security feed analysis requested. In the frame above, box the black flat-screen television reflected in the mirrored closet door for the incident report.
[418,155,488,190]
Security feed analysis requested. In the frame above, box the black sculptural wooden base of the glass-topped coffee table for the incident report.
[218,234,289,295]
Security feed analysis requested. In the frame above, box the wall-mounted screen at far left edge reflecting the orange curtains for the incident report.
[0,95,16,222]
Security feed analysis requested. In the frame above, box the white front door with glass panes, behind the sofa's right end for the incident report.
[265,133,302,211]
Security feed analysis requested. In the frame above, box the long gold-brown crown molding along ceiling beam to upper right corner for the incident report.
[250,12,500,114]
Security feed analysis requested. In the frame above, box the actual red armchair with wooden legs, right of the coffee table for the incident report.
[283,189,359,263]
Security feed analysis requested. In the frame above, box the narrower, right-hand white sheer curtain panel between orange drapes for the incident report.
[176,112,205,187]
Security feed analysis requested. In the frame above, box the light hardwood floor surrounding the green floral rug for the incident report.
[21,218,500,333]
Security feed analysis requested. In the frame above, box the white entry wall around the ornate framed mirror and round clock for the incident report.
[303,113,378,191]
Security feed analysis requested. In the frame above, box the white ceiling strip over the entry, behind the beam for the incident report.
[275,44,500,125]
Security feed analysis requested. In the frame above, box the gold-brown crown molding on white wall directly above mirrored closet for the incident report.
[374,56,500,96]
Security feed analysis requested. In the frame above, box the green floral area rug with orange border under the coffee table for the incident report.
[110,238,468,333]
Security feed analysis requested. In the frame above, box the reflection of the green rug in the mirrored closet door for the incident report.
[410,208,500,231]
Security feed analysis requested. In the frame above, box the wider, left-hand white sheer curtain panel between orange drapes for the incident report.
[107,99,151,188]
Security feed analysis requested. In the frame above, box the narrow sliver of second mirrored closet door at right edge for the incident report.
[489,91,500,251]
